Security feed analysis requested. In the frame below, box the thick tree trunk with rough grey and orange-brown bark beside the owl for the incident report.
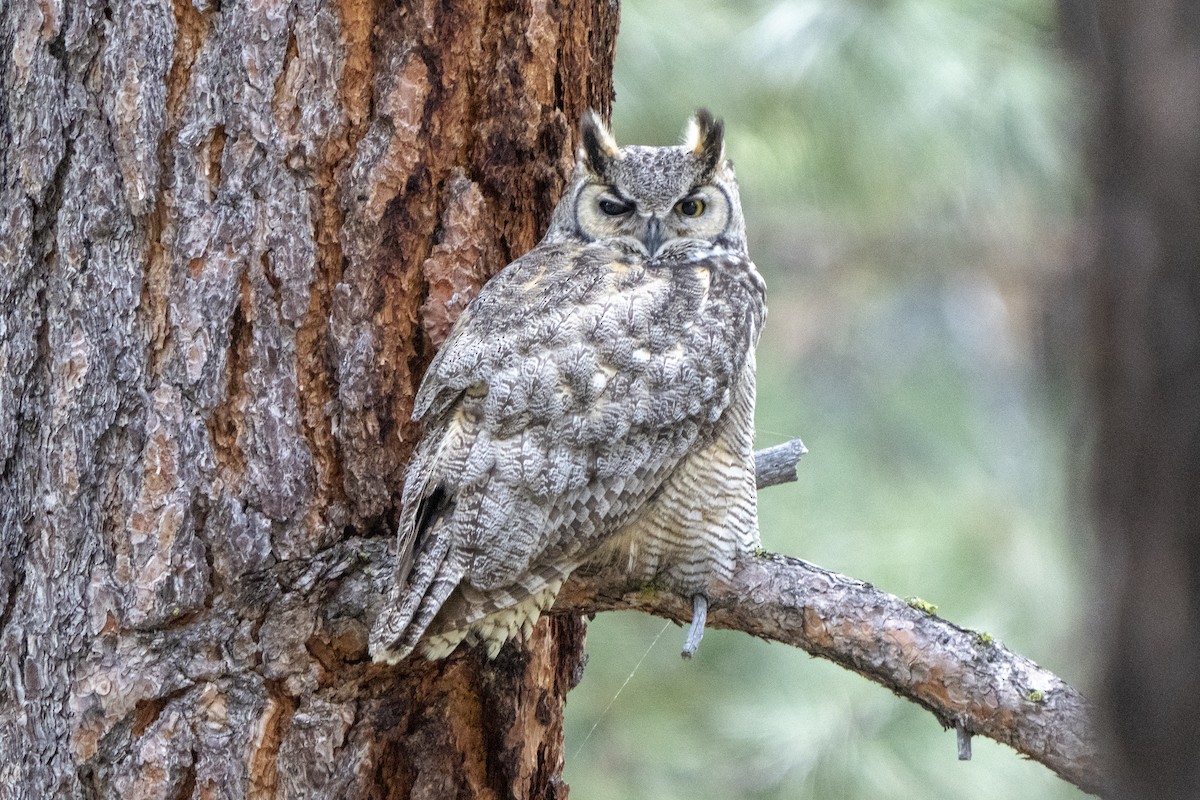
[0,0,617,800]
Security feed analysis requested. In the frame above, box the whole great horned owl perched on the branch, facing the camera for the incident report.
[371,110,766,662]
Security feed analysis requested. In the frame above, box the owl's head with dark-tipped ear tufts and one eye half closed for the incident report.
[546,109,746,260]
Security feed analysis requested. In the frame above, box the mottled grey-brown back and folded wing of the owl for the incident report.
[364,245,763,658]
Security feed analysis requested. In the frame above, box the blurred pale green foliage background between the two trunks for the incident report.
[566,0,1092,800]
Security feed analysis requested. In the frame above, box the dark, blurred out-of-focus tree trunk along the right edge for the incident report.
[1061,0,1200,800]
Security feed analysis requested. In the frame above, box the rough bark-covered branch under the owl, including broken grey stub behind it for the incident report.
[553,440,1100,793]
